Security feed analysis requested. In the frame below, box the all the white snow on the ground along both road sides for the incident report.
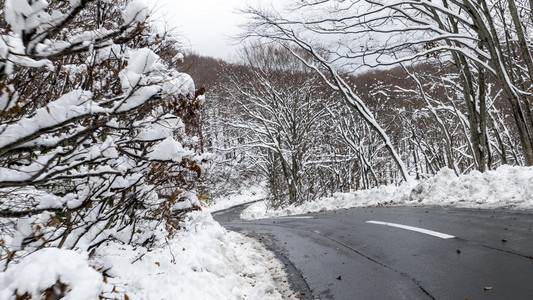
[4,166,533,300]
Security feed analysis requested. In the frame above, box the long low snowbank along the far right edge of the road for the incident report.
[241,166,533,220]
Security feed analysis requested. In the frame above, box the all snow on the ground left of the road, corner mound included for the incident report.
[0,212,297,300]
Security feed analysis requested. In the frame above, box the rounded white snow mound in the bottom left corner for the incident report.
[0,248,104,300]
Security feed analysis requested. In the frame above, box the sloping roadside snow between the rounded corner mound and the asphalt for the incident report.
[94,212,291,299]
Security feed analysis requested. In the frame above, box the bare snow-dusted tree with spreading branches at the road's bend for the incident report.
[221,44,353,207]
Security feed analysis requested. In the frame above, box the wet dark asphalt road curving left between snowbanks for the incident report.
[213,206,533,300]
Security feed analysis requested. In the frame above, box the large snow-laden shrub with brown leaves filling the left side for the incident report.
[0,0,205,278]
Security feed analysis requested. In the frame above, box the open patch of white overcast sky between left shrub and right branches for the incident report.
[146,0,262,59]
